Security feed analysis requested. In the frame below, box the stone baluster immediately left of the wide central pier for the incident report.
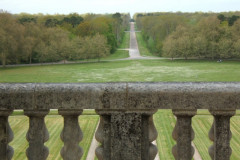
[58,109,83,160]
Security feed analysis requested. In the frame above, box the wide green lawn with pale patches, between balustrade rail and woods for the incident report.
[0,60,240,83]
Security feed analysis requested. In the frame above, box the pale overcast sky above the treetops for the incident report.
[0,0,240,15]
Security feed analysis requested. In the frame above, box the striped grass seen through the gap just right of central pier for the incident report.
[154,110,176,160]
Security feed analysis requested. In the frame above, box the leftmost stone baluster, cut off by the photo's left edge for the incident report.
[0,110,14,160]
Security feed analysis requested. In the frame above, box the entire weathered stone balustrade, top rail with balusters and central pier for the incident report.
[0,83,240,160]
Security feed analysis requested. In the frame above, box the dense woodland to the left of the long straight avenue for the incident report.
[0,10,130,66]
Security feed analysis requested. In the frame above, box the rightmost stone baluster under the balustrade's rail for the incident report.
[208,110,235,160]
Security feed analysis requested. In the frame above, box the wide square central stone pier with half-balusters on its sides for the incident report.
[95,110,158,160]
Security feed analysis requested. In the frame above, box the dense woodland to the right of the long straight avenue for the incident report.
[134,12,240,59]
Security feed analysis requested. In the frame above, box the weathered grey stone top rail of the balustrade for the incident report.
[0,82,240,110]
